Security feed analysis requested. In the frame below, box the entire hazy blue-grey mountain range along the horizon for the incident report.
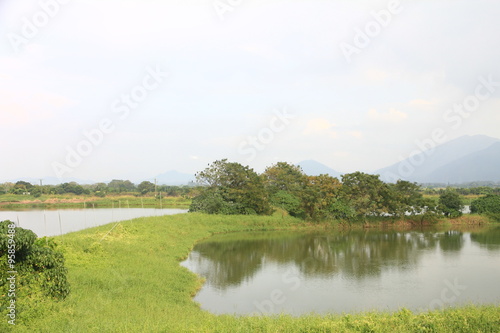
[4,135,500,185]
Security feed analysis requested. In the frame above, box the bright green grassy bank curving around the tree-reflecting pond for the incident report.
[0,214,500,332]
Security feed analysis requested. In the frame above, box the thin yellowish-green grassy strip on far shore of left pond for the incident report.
[0,194,191,210]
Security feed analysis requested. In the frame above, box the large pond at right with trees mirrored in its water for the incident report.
[181,227,500,315]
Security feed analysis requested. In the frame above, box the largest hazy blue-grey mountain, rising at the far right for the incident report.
[375,135,500,183]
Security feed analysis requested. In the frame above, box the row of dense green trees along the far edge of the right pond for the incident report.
[190,160,463,220]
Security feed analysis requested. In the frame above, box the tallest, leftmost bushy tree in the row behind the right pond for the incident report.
[190,159,272,215]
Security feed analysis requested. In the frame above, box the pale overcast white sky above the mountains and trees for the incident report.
[0,0,500,181]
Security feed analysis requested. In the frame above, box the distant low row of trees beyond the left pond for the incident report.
[0,179,197,197]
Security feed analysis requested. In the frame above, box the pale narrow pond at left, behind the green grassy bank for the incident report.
[0,208,187,237]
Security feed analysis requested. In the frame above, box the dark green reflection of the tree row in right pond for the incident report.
[190,231,464,289]
